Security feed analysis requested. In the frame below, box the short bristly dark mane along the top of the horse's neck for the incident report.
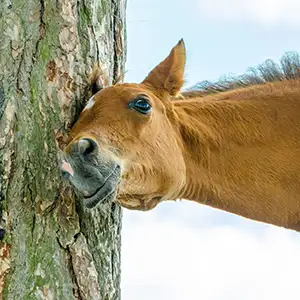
[181,52,300,98]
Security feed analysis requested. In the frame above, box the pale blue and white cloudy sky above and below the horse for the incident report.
[121,0,300,300]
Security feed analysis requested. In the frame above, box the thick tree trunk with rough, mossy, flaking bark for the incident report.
[0,0,126,300]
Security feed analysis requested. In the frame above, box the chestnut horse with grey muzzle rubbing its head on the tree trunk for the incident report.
[62,40,300,231]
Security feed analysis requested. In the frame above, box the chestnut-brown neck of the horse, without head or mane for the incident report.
[174,91,300,230]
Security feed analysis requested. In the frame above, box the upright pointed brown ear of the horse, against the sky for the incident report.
[142,39,186,96]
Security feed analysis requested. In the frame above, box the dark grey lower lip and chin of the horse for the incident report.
[83,166,120,209]
